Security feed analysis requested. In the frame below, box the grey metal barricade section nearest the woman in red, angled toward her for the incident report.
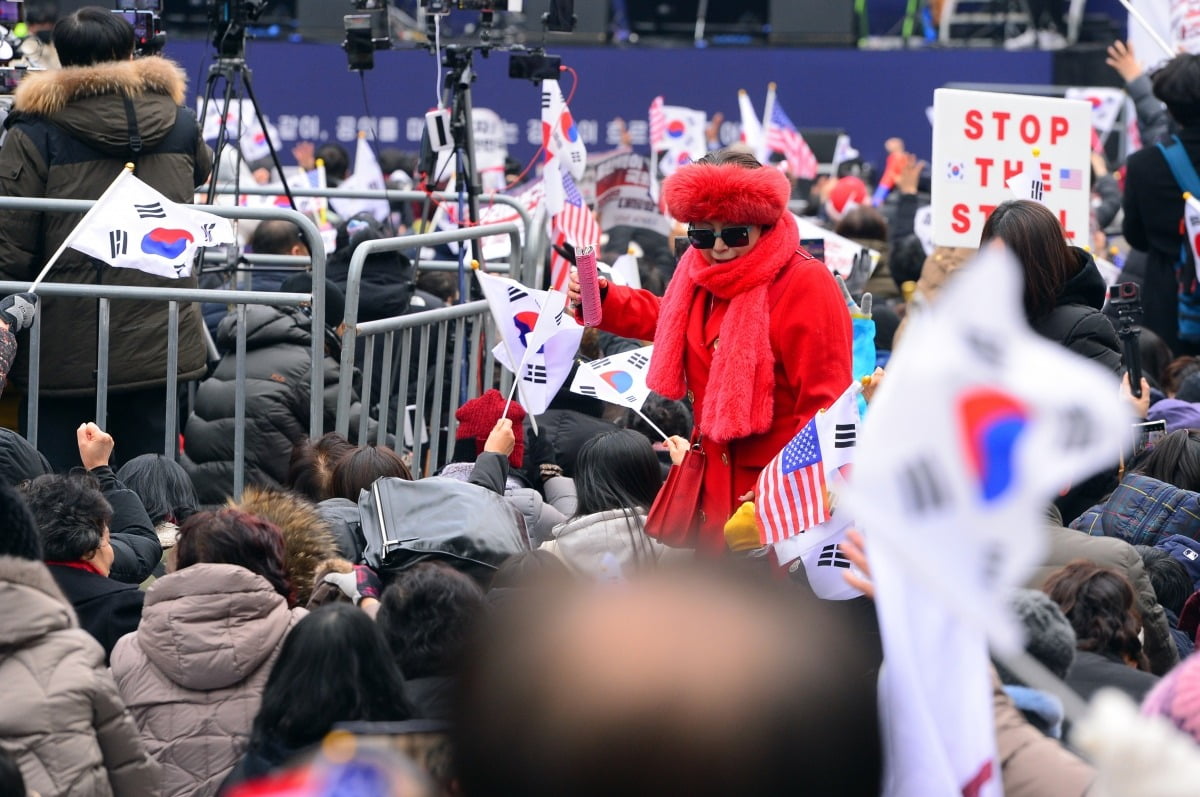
[335,224,521,475]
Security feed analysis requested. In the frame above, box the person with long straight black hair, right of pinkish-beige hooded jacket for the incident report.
[222,604,413,792]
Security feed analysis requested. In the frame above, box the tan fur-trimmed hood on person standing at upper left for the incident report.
[13,56,187,152]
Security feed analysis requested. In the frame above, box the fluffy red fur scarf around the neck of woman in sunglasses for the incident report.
[647,214,800,443]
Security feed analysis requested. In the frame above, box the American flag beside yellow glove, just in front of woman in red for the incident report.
[755,418,830,545]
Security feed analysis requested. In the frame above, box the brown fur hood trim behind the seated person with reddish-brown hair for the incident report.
[229,487,337,606]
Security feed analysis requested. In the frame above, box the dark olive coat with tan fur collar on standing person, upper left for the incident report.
[0,58,212,395]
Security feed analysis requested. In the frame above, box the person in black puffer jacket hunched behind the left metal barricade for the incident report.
[182,274,376,504]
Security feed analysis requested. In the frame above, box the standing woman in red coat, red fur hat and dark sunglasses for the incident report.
[570,150,852,551]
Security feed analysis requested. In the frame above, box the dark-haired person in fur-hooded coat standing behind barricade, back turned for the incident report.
[0,6,212,468]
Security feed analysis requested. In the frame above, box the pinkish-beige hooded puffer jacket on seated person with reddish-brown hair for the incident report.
[112,564,307,797]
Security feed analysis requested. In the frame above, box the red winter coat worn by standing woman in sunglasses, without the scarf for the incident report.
[601,253,853,551]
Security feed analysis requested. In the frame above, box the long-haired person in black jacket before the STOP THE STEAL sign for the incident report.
[979,199,1121,373]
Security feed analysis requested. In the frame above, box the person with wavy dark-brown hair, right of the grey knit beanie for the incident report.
[1043,559,1158,702]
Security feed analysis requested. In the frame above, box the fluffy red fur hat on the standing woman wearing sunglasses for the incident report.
[662,163,792,226]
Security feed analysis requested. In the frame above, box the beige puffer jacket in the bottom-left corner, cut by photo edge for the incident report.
[0,556,158,797]
